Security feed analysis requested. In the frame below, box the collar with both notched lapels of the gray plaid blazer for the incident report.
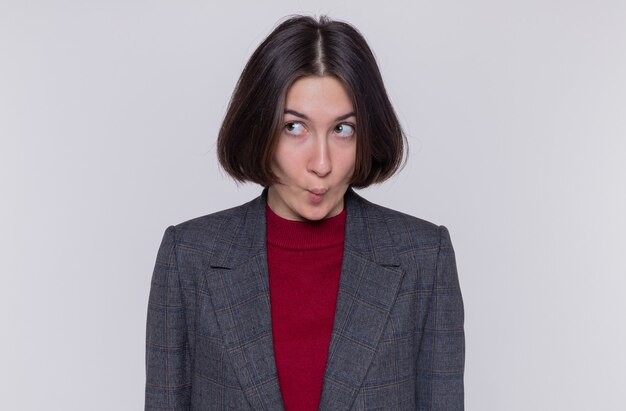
[205,189,403,410]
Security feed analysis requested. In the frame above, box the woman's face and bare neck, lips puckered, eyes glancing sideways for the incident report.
[267,76,357,221]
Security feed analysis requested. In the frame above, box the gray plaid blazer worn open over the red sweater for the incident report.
[145,190,465,411]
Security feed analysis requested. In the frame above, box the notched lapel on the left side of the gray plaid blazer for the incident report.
[205,192,284,410]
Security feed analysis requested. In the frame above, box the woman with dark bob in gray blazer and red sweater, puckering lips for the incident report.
[146,17,465,411]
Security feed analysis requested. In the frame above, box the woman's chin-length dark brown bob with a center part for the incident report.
[217,16,407,188]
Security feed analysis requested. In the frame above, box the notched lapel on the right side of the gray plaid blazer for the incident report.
[319,190,404,410]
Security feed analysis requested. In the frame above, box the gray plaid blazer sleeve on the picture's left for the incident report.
[145,226,191,411]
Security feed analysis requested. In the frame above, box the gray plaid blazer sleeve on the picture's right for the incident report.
[417,226,465,411]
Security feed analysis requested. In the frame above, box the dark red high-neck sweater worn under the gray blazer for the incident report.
[266,206,346,411]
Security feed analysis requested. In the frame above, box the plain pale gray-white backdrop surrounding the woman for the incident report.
[0,0,626,411]
